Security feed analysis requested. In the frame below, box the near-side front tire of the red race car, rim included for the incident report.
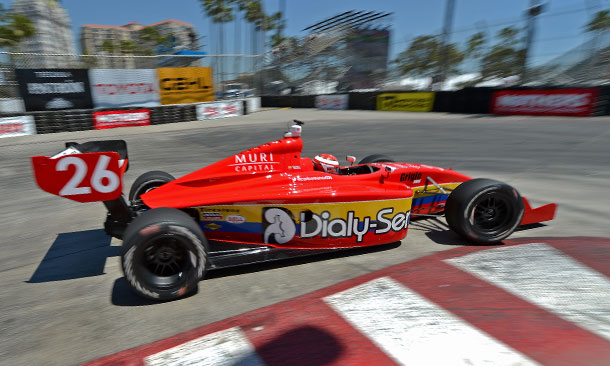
[445,178,523,244]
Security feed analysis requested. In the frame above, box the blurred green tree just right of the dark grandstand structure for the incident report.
[394,36,465,76]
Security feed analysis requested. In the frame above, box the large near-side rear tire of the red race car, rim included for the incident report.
[121,207,208,301]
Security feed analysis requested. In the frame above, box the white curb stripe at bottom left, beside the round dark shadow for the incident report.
[144,328,264,366]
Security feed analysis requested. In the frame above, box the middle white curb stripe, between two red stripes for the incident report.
[324,277,536,365]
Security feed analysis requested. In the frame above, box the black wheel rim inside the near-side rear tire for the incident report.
[141,236,192,288]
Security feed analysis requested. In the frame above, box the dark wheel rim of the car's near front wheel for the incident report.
[470,193,513,236]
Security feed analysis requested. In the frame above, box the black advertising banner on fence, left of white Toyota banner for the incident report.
[15,69,93,112]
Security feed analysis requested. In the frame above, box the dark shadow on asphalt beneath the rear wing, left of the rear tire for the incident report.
[26,229,119,283]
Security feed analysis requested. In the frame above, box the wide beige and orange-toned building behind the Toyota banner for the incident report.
[80,19,199,68]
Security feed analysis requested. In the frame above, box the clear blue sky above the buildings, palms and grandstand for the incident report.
[1,0,610,68]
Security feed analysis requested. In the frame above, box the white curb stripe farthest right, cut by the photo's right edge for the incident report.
[446,243,610,340]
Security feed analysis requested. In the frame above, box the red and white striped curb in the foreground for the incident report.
[86,237,610,366]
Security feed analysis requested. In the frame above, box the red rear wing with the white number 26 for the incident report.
[31,140,129,202]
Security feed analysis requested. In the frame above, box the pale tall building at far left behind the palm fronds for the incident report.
[12,0,75,68]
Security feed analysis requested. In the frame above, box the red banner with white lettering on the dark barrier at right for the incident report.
[492,89,599,116]
